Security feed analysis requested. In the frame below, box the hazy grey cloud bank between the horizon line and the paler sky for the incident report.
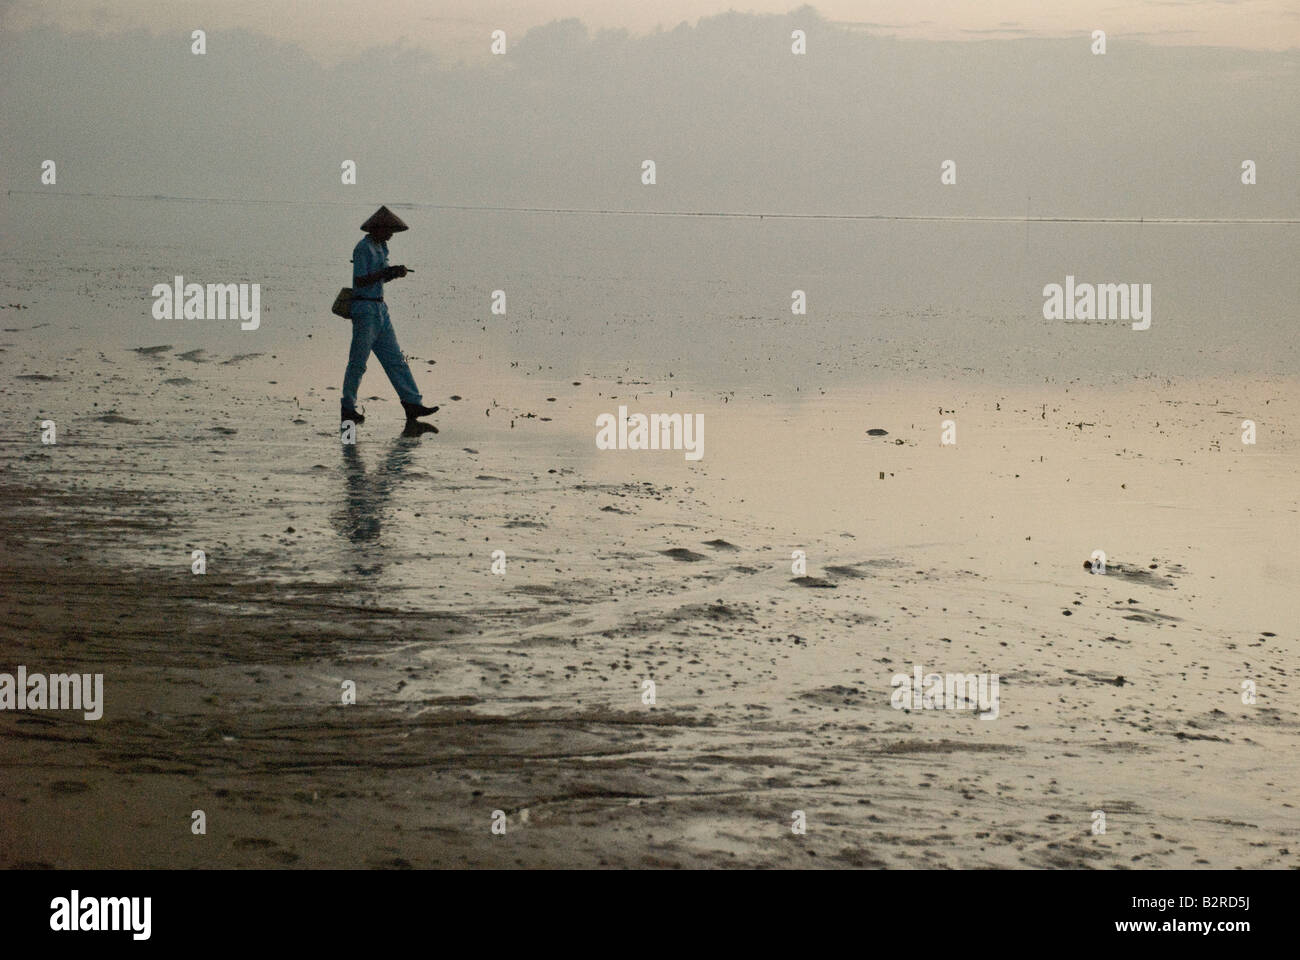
[0,0,1300,219]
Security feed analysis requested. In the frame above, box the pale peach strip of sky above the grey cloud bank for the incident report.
[0,0,1300,64]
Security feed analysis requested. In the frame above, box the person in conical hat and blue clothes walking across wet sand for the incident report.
[339,207,438,423]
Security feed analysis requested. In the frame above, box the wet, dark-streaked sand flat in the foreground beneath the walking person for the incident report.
[0,325,1300,868]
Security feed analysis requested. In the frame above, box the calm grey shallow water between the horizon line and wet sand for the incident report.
[10,195,1300,397]
